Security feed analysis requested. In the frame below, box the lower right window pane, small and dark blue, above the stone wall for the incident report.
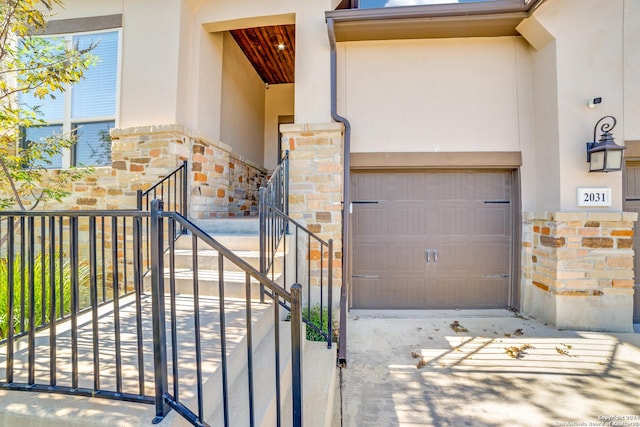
[74,121,115,166]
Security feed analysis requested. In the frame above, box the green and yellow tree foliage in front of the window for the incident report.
[0,0,95,210]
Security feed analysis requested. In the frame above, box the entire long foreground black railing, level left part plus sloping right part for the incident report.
[0,205,302,426]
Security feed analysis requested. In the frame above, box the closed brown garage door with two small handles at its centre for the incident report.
[351,171,513,308]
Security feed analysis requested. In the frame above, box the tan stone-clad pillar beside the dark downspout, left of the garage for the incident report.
[280,123,344,286]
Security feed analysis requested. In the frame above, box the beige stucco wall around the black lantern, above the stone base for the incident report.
[519,0,638,211]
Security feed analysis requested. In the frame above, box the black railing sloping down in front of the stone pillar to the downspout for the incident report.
[262,204,337,348]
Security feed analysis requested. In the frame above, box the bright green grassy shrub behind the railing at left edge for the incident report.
[0,253,90,339]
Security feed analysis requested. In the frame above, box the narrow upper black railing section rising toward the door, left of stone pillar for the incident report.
[258,151,289,274]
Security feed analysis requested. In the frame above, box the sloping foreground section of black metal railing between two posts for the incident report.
[150,200,302,427]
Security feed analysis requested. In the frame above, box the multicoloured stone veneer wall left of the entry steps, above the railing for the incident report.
[36,125,266,219]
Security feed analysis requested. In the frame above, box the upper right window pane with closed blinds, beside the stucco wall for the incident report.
[71,31,118,119]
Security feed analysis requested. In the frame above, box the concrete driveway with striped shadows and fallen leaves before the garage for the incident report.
[341,310,640,427]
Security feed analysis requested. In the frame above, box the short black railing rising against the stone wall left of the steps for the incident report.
[137,160,189,274]
